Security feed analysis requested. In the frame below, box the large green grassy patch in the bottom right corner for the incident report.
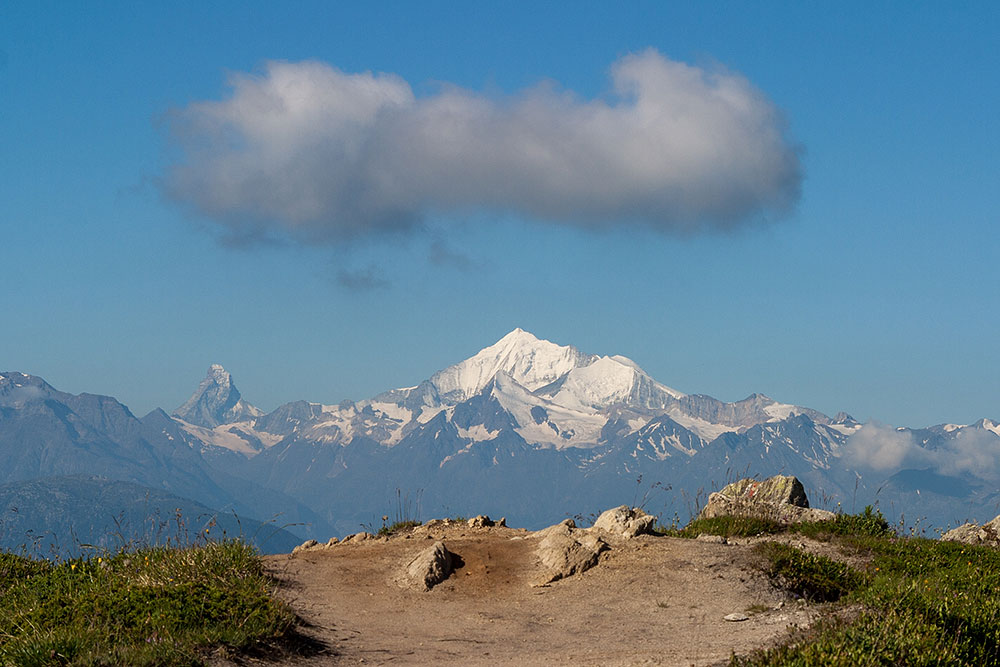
[732,513,1000,666]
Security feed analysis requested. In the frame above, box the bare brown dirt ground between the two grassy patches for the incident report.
[246,523,819,666]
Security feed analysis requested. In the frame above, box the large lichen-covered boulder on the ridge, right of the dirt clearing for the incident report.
[698,475,836,523]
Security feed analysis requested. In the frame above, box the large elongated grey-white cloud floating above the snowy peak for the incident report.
[163,50,801,242]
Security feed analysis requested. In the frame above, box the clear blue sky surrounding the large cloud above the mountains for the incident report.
[0,2,1000,426]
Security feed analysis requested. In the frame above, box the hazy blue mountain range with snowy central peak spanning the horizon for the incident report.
[0,329,1000,540]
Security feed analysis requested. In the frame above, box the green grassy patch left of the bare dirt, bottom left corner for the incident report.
[0,541,295,665]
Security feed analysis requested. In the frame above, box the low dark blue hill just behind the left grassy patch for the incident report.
[0,475,302,556]
